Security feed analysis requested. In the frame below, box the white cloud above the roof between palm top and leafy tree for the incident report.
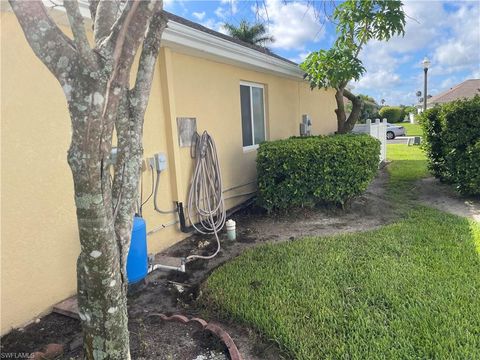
[252,0,324,50]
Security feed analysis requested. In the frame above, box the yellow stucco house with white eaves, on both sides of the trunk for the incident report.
[0,5,336,334]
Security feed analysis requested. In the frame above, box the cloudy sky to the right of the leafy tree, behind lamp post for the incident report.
[355,1,480,104]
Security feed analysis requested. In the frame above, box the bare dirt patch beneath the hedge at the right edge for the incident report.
[415,177,480,222]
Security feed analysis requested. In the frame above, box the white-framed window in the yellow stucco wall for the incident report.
[240,83,265,149]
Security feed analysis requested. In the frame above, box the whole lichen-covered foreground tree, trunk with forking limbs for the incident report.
[10,0,167,360]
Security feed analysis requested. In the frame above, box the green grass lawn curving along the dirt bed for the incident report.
[202,145,480,360]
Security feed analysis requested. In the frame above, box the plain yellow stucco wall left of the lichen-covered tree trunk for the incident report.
[0,13,79,333]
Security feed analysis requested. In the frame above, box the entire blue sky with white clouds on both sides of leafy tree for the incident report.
[164,0,480,105]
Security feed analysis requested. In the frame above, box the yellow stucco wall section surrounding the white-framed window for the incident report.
[172,53,336,205]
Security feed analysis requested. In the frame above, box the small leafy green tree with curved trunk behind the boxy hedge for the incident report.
[300,0,405,133]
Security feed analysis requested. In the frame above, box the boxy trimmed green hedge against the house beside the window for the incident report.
[257,134,380,211]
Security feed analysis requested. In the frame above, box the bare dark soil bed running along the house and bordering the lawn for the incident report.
[1,169,395,360]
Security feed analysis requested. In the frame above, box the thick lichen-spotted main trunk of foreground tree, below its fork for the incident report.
[68,76,130,359]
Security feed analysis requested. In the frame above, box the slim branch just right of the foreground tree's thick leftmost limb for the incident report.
[63,0,98,70]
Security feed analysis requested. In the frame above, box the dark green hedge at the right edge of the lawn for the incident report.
[420,96,480,195]
